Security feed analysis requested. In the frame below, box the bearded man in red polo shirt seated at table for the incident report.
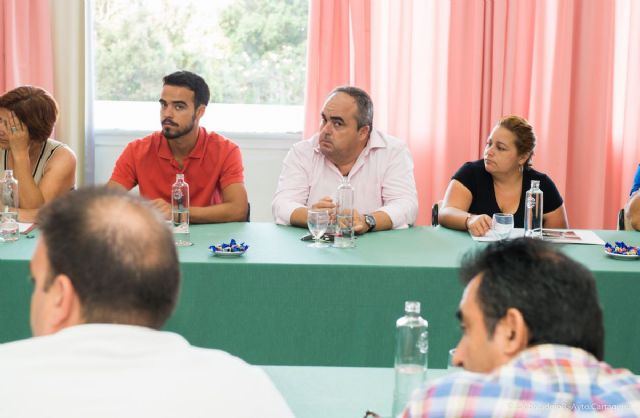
[108,71,248,223]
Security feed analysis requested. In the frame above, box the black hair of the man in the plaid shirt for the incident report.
[460,238,604,360]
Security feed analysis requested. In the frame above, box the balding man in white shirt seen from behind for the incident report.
[0,188,293,418]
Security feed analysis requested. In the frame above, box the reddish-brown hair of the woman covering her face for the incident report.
[0,86,58,142]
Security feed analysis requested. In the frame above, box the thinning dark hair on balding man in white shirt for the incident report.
[38,187,180,328]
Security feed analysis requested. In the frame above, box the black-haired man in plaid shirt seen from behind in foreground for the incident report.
[403,238,640,418]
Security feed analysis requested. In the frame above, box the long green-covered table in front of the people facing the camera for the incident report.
[0,223,640,373]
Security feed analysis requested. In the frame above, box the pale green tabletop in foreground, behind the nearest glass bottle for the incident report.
[262,366,449,418]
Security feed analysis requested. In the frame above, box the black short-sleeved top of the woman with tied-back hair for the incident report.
[452,160,563,228]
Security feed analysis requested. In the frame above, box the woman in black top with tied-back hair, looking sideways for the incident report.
[438,116,568,236]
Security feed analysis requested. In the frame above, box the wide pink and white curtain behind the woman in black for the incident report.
[305,0,640,229]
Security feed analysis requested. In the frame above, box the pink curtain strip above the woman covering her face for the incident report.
[0,0,53,93]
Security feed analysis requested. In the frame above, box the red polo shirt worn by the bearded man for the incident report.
[111,128,244,207]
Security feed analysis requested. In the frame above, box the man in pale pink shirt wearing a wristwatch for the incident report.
[272,86,418,234]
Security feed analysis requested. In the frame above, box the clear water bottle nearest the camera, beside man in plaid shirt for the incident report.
[392,302,429,417]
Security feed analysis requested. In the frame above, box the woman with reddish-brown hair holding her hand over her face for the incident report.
[0,86,76,221]
